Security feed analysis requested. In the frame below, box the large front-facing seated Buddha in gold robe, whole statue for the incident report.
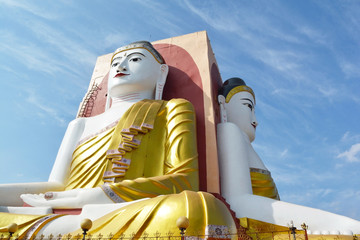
[0,41,235,238]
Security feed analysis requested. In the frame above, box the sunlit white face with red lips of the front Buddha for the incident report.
[108,48,161,97]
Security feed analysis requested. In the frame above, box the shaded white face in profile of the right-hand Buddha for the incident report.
[225,91,258,142]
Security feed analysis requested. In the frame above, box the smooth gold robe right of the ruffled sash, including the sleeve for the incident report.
[110,99,198,201]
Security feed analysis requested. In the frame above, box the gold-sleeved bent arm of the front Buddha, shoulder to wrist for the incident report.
[103,99,198,201]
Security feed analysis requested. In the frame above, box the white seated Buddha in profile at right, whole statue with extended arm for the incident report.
[217,78,360,235]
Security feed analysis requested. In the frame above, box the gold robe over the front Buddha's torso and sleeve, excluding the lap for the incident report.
[66,99,198,196]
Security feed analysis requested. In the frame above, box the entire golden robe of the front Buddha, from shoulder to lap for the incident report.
[0,99,235,238]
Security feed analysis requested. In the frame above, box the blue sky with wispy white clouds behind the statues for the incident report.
[0,0,360,220]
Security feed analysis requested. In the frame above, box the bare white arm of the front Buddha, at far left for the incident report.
[0,119,84,206]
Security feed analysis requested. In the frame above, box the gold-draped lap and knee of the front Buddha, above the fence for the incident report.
[0,191,236,237]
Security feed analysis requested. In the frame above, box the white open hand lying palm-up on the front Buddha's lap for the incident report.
[20,187,113,208]
